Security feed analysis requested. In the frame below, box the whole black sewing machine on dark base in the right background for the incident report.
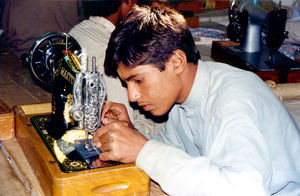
[212,0,300,82]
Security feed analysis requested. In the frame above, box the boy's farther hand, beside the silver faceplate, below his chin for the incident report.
[101,101,133,128]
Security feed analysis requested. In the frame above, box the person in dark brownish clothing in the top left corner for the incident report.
[1,0,80,59]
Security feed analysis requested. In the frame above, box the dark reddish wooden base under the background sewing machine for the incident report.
[211,41,300,83]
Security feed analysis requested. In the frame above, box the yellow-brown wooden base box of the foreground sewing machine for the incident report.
[14,103,150,195]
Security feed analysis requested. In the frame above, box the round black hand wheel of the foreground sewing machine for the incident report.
[28,32,81,91]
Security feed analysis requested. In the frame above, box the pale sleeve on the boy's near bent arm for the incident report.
[136,99,271,195]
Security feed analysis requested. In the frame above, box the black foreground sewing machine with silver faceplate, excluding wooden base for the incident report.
[29,32,106,159]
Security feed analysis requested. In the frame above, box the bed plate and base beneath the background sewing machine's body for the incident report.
[211,41,300,83]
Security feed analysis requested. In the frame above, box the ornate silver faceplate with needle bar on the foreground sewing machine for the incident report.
[70,57,106,149]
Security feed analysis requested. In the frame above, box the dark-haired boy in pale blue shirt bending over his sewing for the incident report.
[94,5,300,196]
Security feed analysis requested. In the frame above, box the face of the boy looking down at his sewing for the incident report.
[117,63,180,116]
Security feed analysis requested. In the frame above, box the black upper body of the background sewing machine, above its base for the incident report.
[227,0,287,53]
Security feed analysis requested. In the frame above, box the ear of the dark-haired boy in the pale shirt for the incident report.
[167,49,187,74]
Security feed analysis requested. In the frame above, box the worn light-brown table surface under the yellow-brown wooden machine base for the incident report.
[0,138,166,196]
